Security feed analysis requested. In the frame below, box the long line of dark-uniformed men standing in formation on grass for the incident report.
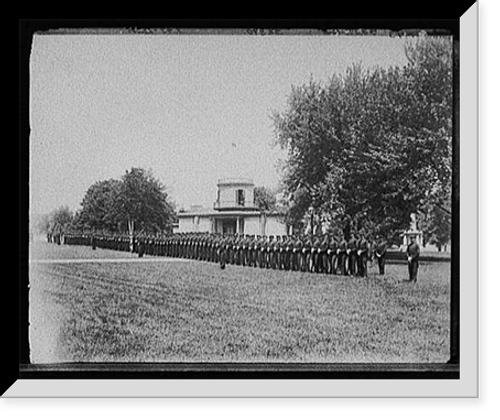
[55,232,402,277]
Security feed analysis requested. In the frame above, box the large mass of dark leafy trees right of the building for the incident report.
[272,36,452,246]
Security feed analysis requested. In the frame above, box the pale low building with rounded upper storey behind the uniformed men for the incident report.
[176,178,289,236]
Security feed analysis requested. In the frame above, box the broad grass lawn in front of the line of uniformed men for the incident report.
[30,243,450,363]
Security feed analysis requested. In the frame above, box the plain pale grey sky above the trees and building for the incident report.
[30,34,406,213]
